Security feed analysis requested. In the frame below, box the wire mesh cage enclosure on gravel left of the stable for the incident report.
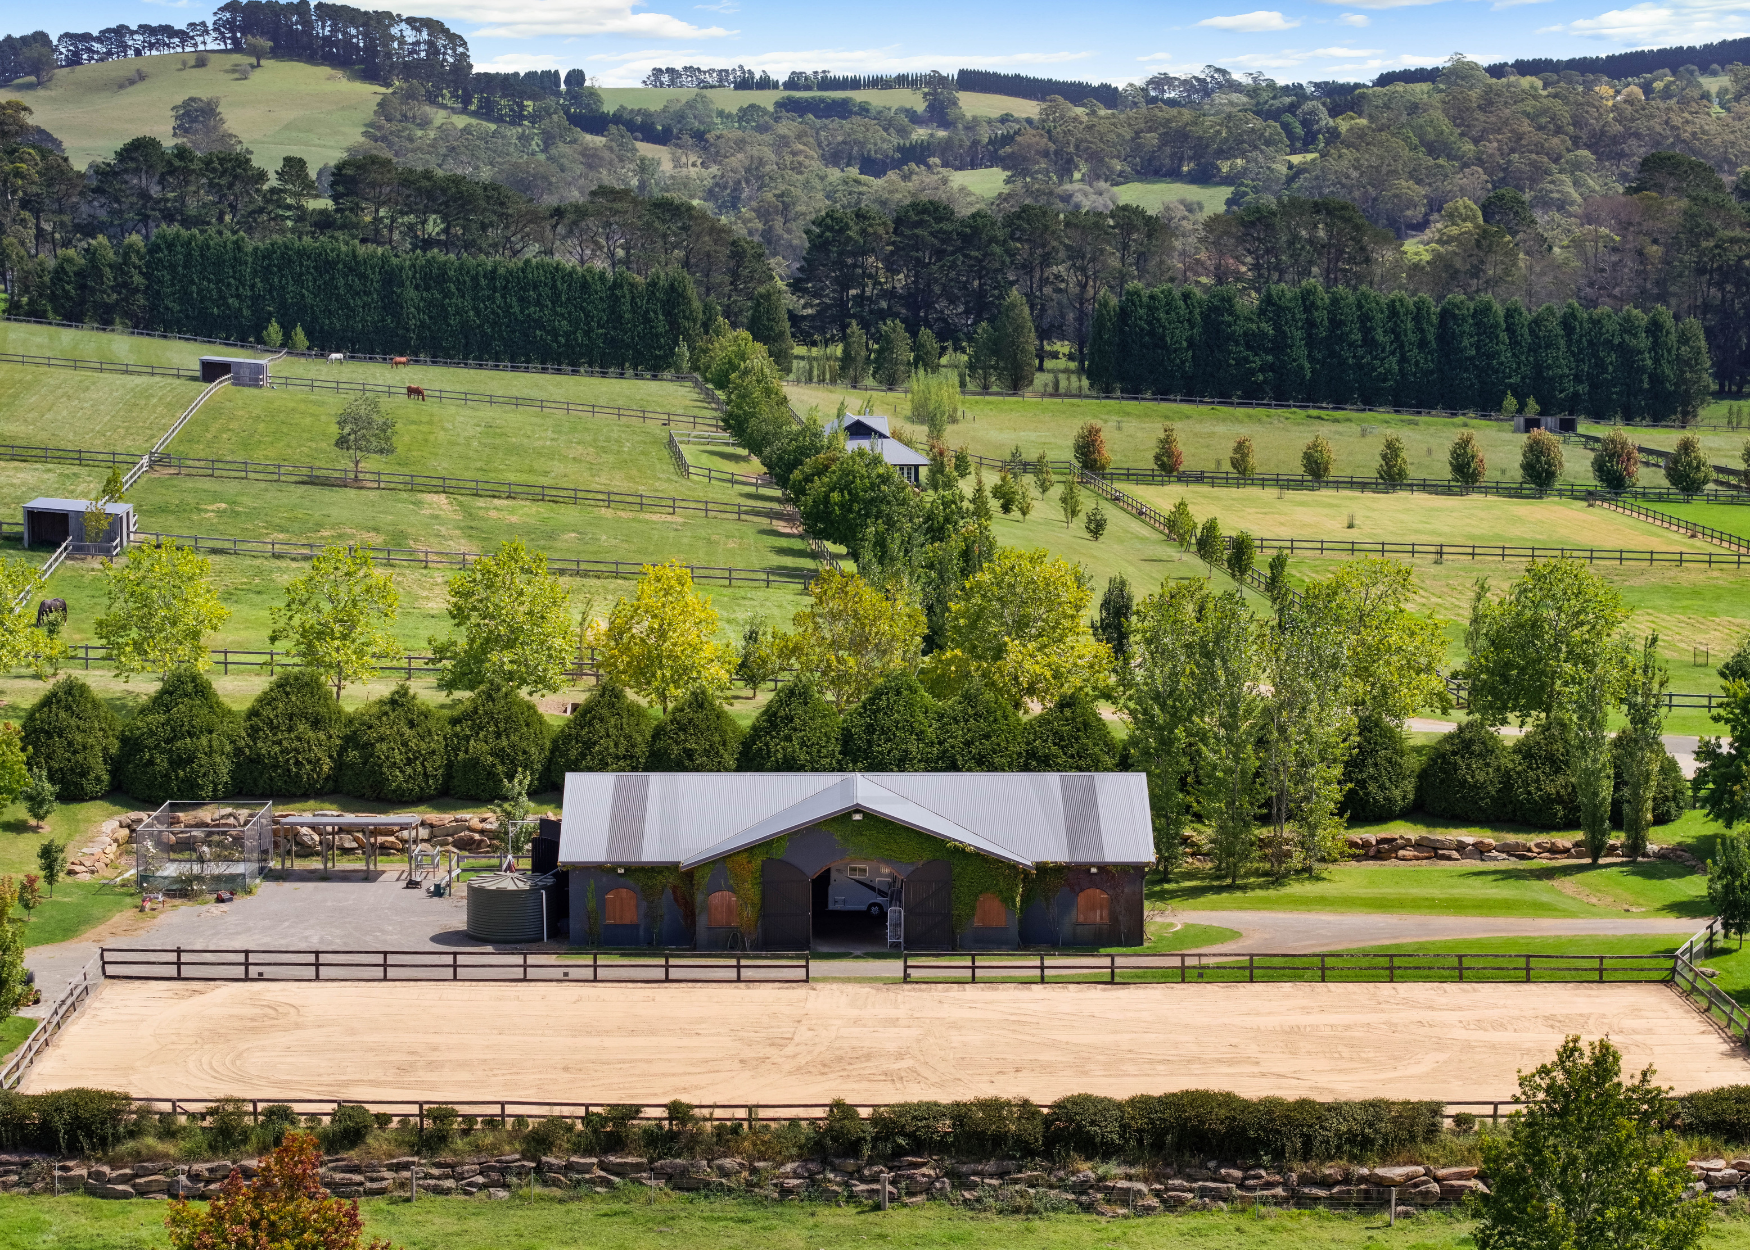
[133,802,273,896]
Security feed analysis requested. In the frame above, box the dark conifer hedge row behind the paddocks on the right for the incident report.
[1089,280,1713,422]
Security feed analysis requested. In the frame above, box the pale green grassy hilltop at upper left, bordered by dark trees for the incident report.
[0,53,383,178]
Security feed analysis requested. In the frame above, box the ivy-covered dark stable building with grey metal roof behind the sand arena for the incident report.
[557,772,1155,951]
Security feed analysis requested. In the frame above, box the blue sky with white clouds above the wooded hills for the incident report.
[30,0,1750,86]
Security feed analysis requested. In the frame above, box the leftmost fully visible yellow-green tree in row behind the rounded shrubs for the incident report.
[93,539,231,681]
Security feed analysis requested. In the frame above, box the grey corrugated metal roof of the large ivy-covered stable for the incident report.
[558,772,1155,867]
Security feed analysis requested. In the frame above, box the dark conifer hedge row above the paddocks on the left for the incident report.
[145,228,716,371]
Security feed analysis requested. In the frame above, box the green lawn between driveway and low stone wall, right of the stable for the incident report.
[1148,850,1713,924]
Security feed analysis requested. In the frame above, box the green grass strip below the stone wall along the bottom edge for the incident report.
[0,1192,1519,1250]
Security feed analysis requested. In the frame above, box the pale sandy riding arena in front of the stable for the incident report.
[25,980,1750,1103]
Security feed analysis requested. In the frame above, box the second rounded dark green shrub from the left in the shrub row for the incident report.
[117,669,243,804]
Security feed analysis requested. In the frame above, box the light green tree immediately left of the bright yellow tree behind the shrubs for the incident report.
[431,539,576,695]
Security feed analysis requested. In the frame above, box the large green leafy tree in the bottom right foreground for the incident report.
[1475,1035,1713,1250]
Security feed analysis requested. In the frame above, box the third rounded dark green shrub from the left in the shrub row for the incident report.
[236,669,347,798]
